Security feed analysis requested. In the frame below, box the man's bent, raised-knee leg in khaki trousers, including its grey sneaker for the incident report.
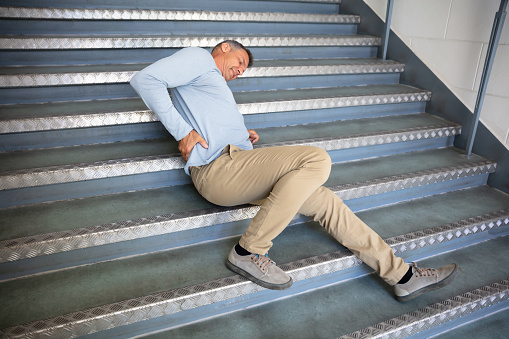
[191,146,331,289]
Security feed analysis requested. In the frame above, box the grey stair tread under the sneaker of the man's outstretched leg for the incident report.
[155,237,509,339]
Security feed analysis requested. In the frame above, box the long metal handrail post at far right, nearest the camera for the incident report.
[466,0,508,157]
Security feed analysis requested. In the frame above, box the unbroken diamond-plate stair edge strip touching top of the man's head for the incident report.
[0,35,381,50]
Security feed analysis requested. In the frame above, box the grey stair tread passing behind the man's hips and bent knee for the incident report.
[0,148,492,240]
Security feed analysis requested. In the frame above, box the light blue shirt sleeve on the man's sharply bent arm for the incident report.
[130,48,213,140]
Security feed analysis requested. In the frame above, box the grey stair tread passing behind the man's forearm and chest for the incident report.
[0,84,429,121]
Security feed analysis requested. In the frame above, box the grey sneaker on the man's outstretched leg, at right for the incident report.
[394,263,460,301]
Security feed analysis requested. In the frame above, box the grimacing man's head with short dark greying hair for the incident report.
[212,40,253,81]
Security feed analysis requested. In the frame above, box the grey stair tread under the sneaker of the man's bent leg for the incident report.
[0,187,509,334]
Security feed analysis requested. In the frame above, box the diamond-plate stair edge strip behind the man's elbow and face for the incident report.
[0,62,404,87]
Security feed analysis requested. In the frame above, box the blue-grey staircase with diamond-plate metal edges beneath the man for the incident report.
[0,0,509,338]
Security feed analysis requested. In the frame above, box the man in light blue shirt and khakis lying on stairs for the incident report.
[131,40,459,300]
